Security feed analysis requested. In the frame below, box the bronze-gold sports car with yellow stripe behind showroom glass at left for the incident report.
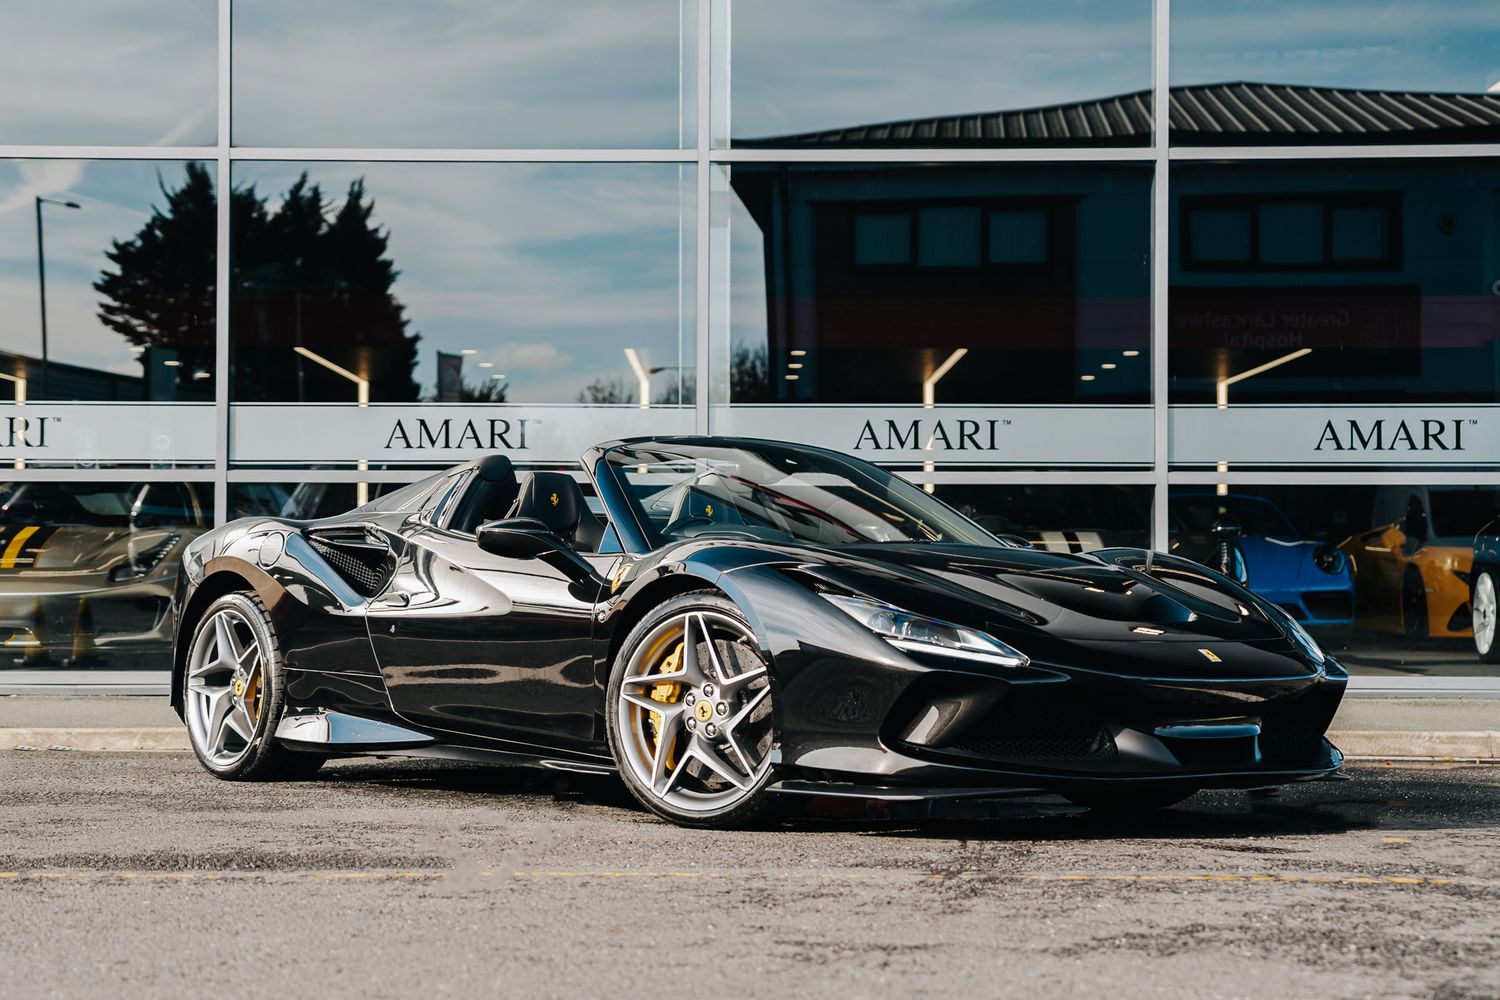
[0,481,213,669]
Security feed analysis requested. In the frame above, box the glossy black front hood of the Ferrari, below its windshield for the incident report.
[804,544,1284,642]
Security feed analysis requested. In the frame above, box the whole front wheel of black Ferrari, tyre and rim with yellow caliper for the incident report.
[605,594,776,828]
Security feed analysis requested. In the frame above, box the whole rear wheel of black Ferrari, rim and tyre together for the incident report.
[183,594,324,781]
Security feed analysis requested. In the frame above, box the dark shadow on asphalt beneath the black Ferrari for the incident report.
[307,760,1500,841]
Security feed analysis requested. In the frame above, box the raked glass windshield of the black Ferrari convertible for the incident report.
[605,442,1001,547]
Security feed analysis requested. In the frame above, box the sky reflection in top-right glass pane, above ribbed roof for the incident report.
[1172,0,1500,93]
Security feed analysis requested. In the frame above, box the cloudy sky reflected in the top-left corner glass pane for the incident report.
[0,0,219,145]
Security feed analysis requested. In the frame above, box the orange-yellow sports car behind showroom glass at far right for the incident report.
[1340,486,1497,639]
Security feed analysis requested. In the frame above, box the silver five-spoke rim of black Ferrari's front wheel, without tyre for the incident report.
[617,610,773,813]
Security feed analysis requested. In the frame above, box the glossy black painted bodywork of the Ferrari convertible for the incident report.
[174,438,1346,789]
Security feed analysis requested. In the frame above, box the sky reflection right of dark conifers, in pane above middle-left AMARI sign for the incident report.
[231,163,693,402]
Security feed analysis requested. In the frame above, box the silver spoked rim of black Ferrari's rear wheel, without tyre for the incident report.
[188,607,266,769]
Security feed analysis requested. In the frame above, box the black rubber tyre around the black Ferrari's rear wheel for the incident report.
[183,592,327,781]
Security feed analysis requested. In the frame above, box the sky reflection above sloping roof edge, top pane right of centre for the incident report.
[732,0,1152,138]
